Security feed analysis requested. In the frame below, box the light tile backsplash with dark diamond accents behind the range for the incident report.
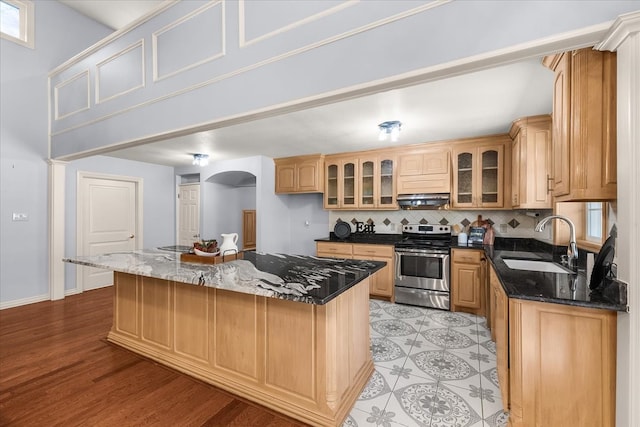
[329,210,552,242]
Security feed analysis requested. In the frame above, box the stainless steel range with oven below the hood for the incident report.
[395,224,451,310]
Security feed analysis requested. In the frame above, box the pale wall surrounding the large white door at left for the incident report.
[65,156,176,291]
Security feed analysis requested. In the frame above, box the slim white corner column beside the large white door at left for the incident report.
[47,159,68,300]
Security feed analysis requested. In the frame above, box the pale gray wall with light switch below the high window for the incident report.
[0,1,111,306]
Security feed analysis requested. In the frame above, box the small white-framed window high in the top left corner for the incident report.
[0,0,34,49]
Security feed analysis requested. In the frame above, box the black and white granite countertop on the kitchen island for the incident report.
[64,249,386,305]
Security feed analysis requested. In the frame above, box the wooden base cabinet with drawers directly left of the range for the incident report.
[316,242,395,302]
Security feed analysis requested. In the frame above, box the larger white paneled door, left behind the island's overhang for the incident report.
[78,176,138,290]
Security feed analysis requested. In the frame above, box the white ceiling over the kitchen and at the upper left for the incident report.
[60,0,553,166]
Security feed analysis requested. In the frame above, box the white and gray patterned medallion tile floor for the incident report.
[343,300,507,427]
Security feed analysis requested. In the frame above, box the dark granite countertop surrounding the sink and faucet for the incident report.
[452,239,627,311]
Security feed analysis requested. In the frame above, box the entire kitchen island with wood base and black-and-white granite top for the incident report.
[65,250,384,426]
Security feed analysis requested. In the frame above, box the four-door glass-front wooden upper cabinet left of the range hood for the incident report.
[324,152,398,210]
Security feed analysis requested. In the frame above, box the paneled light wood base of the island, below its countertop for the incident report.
[108,273,373,425]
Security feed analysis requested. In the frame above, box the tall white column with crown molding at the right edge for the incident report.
[596,12,640,426]
